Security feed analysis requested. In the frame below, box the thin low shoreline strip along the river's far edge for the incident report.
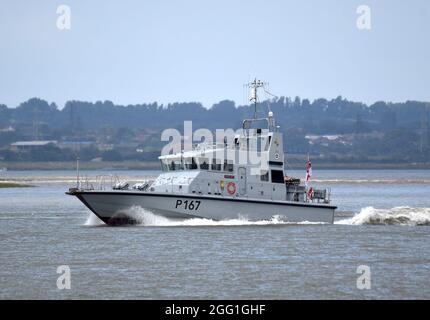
[0,159,430,170]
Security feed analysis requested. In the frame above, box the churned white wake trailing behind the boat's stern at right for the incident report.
[335,206,430,226]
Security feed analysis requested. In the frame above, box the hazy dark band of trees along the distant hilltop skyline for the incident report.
[0,97,430,134]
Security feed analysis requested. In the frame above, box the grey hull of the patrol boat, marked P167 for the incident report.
[69,191,336,225]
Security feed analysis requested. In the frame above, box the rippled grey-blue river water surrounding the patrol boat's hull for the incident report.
[0,170,430,299]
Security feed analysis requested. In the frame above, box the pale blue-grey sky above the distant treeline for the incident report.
[0,0,430,108]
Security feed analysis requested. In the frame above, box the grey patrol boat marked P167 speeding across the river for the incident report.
[67,80,336,225]
